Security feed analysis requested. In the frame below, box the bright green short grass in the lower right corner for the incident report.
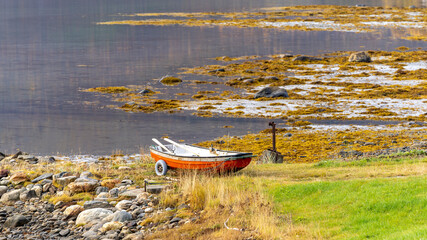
[267,175,427,239]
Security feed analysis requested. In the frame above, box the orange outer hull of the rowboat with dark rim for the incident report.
[150,149,252,172]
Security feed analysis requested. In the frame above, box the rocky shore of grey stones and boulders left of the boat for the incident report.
[0,152,197,240]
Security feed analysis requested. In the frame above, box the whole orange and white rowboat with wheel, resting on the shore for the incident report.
[150,138,253,176]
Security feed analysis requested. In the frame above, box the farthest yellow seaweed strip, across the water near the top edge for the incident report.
[97,5,427,40]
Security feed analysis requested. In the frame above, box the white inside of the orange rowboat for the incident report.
[154,144,240,157]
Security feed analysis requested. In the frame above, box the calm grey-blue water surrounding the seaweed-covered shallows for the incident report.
[0,0,427,154]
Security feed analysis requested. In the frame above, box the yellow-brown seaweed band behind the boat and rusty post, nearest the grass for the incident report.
[200,128,427,163]
